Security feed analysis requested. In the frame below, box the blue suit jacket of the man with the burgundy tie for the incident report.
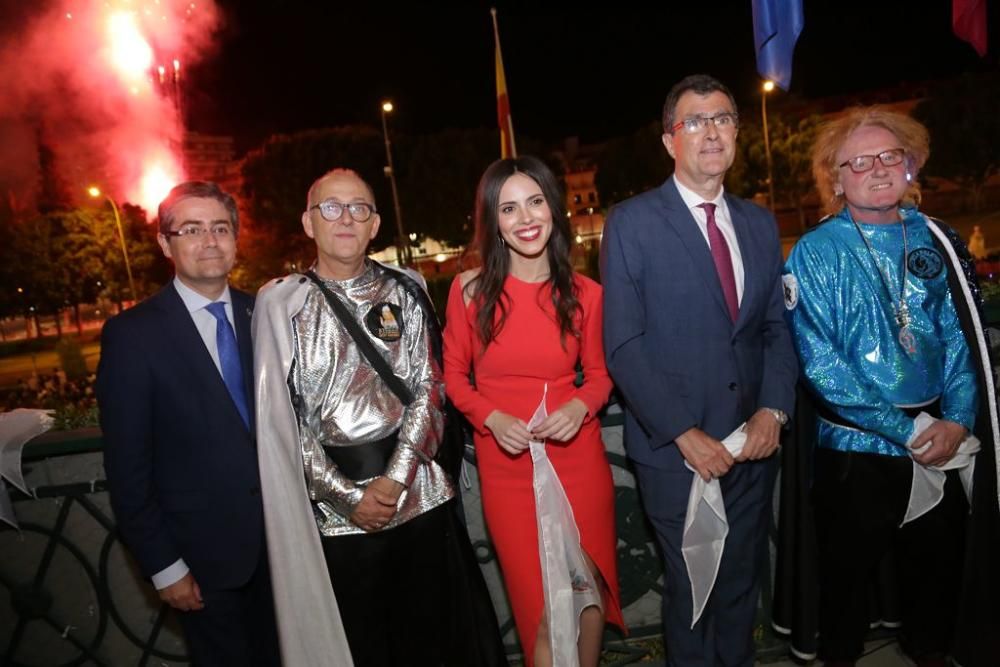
[601,178,798,470]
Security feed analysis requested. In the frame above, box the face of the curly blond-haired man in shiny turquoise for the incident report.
[836,125,909,224]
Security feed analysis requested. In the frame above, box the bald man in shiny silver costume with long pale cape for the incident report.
[253,169,495,666]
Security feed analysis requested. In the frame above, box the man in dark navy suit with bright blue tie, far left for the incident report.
[97,181,278,666]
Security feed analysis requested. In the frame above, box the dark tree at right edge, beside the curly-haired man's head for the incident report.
[913,72,1000,212]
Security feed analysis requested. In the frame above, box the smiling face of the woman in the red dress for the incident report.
[497,172,552,261]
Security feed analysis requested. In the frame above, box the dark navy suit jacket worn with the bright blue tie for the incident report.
[97,283,264,589]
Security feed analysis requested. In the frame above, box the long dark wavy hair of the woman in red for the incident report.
[465,155,580,347]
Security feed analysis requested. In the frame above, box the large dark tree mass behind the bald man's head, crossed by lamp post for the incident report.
[234,126,561,289]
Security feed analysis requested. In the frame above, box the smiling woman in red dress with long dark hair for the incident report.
[444,156,624,667]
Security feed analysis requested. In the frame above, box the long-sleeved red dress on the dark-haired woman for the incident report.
[444,274,624,667]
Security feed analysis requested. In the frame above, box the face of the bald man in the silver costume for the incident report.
[302,170,380,280]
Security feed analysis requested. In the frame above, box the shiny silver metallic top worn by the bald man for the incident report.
[288,261,454,536]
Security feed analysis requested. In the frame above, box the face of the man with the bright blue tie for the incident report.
[157,197,236,298]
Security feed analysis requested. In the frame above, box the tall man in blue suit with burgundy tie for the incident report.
[601,75,797,666]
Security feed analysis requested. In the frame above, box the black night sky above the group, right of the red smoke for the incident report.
[186,0,1000,151]
